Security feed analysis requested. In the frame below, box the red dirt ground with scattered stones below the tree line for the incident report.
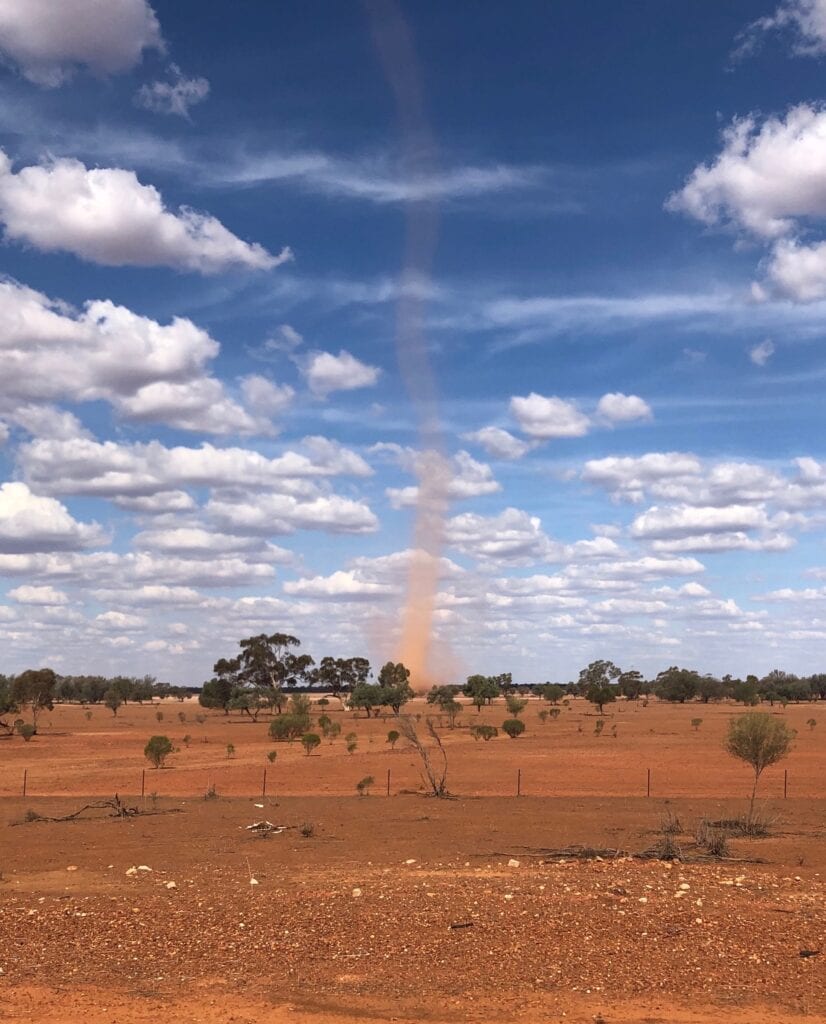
[0,700,826,1024]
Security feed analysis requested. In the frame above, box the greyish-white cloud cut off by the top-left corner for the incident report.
[0,0,164,87]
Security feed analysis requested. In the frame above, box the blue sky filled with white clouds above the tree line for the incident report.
[0,0,826,683]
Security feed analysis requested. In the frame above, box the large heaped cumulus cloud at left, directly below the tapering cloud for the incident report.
[0,281,292,437]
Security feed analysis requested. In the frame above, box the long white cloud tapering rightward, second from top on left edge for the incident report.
[0,152,291,273]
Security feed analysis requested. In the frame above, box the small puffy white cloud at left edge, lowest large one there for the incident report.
[0,483,106,553]
